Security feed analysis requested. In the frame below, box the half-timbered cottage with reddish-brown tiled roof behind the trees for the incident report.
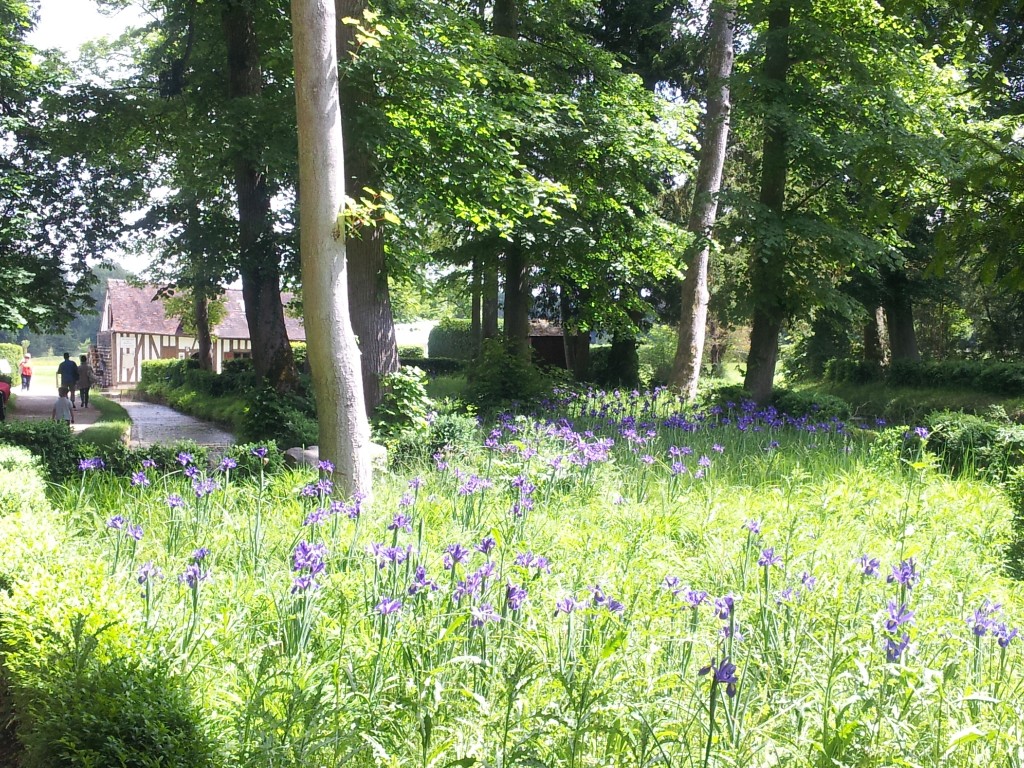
[96,280,306,387]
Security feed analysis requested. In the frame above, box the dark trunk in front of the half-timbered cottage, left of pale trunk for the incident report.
[221,0,298,391]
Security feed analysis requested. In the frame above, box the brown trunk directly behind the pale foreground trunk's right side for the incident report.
[335,0,398,414]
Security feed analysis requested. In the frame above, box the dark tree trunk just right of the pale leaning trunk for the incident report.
[743,0,791,403]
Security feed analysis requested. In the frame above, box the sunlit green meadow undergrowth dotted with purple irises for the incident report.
[0,394,1024,768]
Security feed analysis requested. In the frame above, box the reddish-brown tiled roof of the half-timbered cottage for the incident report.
[106,280,306,341]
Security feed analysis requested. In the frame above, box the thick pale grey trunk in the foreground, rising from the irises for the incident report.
[292,0,373,495]
